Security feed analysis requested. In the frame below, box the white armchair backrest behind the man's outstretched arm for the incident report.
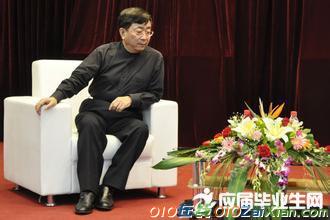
[32,60,90,131]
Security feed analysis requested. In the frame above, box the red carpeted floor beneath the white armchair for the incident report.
[0,142,330,220]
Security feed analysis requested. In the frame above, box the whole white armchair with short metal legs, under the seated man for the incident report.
[4,60,178,206]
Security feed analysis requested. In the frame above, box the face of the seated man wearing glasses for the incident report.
[119,21,153,53]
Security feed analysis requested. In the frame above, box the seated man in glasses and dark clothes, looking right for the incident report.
[35,7,164,214]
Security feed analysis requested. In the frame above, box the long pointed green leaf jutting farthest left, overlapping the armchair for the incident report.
[152,157,202,170]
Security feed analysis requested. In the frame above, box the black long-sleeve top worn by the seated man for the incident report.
[52,42,164,110]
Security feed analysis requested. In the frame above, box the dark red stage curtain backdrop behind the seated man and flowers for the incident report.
[0,0,330,147]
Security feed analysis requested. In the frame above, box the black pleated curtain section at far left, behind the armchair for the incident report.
[0,0,73,139]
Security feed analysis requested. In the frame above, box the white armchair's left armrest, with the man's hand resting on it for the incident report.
[4,96,72,195]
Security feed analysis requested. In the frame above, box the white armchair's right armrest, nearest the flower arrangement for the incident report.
[143,100,178,187]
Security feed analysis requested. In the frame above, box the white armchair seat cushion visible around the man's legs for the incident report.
[71,133,154,161]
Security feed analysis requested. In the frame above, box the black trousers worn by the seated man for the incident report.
[75,99,149,193]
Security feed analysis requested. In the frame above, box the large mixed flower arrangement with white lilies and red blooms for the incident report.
[154,100,330,193]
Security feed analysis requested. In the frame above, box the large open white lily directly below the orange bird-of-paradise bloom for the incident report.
[262,118,293,143]
